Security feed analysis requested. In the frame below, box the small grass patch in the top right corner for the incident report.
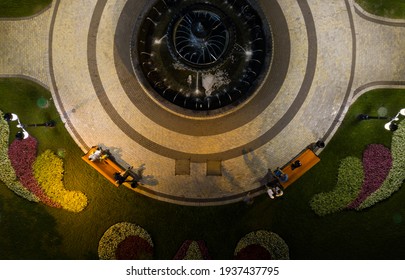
[356,0,405,18]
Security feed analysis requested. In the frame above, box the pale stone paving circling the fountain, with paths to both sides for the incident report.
[0,0,405,205]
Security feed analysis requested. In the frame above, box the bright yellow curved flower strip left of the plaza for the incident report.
[33,150,87,212]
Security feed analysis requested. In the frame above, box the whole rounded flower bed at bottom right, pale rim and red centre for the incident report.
[234,230,289,260]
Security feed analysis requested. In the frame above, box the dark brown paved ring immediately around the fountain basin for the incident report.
[113,0,288,137]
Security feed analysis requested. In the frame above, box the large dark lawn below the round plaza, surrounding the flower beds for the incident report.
[0,79,405,259]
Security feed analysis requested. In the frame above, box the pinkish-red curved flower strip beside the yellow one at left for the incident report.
[8,136,60,207]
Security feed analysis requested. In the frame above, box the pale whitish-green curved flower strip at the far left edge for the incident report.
[0,111,39,202]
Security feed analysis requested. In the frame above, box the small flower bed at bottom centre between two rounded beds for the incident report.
[173,240,211,260]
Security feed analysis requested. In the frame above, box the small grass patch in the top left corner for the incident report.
[0,0,52,18]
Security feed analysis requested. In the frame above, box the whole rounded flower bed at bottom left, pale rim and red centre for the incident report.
[98,222,153,260]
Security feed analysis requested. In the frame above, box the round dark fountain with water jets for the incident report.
[131,0,272,115]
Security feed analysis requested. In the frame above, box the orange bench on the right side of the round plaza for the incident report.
[281,149,320,188]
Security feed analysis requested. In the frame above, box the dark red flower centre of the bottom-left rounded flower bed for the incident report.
[115,235,153,260]
